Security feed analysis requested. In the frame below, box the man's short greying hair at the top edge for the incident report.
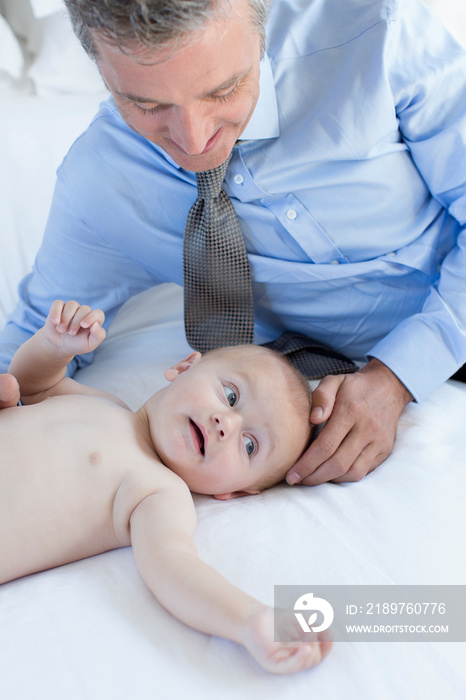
[64,0,271,60]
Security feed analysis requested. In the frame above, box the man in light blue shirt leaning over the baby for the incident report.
[3,0,466,484]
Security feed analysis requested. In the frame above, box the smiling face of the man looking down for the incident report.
[95,0,260,172]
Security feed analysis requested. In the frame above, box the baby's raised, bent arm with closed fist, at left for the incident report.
[8,301,113,403]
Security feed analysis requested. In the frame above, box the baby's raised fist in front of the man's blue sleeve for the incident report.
[43,300,106,355]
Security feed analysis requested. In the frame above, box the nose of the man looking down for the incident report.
[168,103,215,156]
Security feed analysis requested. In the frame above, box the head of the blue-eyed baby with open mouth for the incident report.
[146,345,311,499]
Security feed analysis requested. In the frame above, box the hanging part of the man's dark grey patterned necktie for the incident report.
[183,154,254,352]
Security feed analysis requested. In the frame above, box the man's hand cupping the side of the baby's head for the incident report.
[287,359,413,486]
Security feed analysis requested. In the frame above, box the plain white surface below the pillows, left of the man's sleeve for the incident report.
[0,91,105,328]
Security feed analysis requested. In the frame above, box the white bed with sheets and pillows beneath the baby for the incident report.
[0,0,466,700]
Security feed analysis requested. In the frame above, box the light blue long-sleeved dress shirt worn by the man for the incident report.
[2,0,466,400]
